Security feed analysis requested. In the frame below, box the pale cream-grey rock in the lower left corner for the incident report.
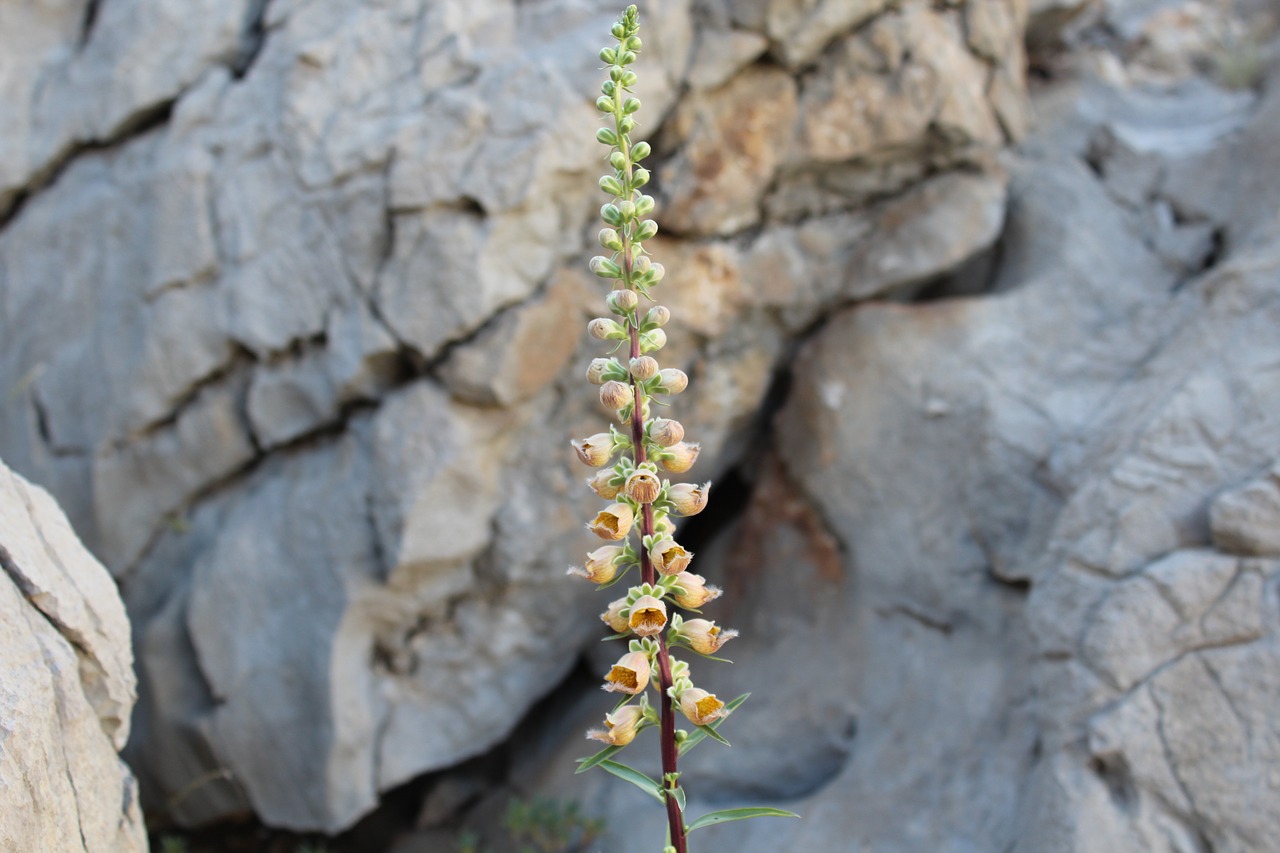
[0,455,147,853]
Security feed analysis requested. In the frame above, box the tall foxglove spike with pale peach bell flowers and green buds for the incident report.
[570,6,794,853]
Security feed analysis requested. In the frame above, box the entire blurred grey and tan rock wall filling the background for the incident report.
[0,0,1280,853]
